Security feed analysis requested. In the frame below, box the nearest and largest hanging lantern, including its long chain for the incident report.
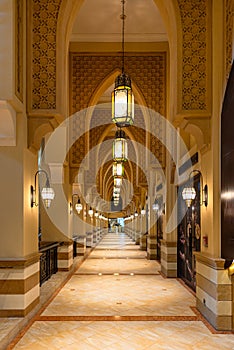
[112,0,134,127]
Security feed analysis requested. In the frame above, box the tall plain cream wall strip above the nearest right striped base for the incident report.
[198,0,226,257]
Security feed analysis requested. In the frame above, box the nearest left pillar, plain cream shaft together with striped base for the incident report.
[0,113,40,317]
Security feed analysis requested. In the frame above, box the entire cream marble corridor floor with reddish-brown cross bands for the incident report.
[7,233,234,350]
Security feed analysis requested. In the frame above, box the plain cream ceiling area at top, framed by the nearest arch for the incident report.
[71,0,167,42]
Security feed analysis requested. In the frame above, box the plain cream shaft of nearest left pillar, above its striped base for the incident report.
[0,114,37,258]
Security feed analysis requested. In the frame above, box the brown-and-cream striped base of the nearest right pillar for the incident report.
[194,252,233,331]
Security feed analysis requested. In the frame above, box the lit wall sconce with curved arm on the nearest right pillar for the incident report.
[182,170,208,207]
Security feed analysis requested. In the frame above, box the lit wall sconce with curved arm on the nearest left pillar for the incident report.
[30,170,55,208]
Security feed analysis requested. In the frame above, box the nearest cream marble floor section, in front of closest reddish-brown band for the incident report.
[12,321,234,350]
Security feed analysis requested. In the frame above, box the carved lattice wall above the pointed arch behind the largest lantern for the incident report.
[70,53,166,115]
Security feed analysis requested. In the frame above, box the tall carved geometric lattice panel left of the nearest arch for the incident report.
[30,0,62,109]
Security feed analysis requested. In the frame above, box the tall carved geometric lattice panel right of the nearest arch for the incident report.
[178,0,210,110]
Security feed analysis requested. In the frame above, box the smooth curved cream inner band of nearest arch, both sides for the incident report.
[57,0,179,118]
